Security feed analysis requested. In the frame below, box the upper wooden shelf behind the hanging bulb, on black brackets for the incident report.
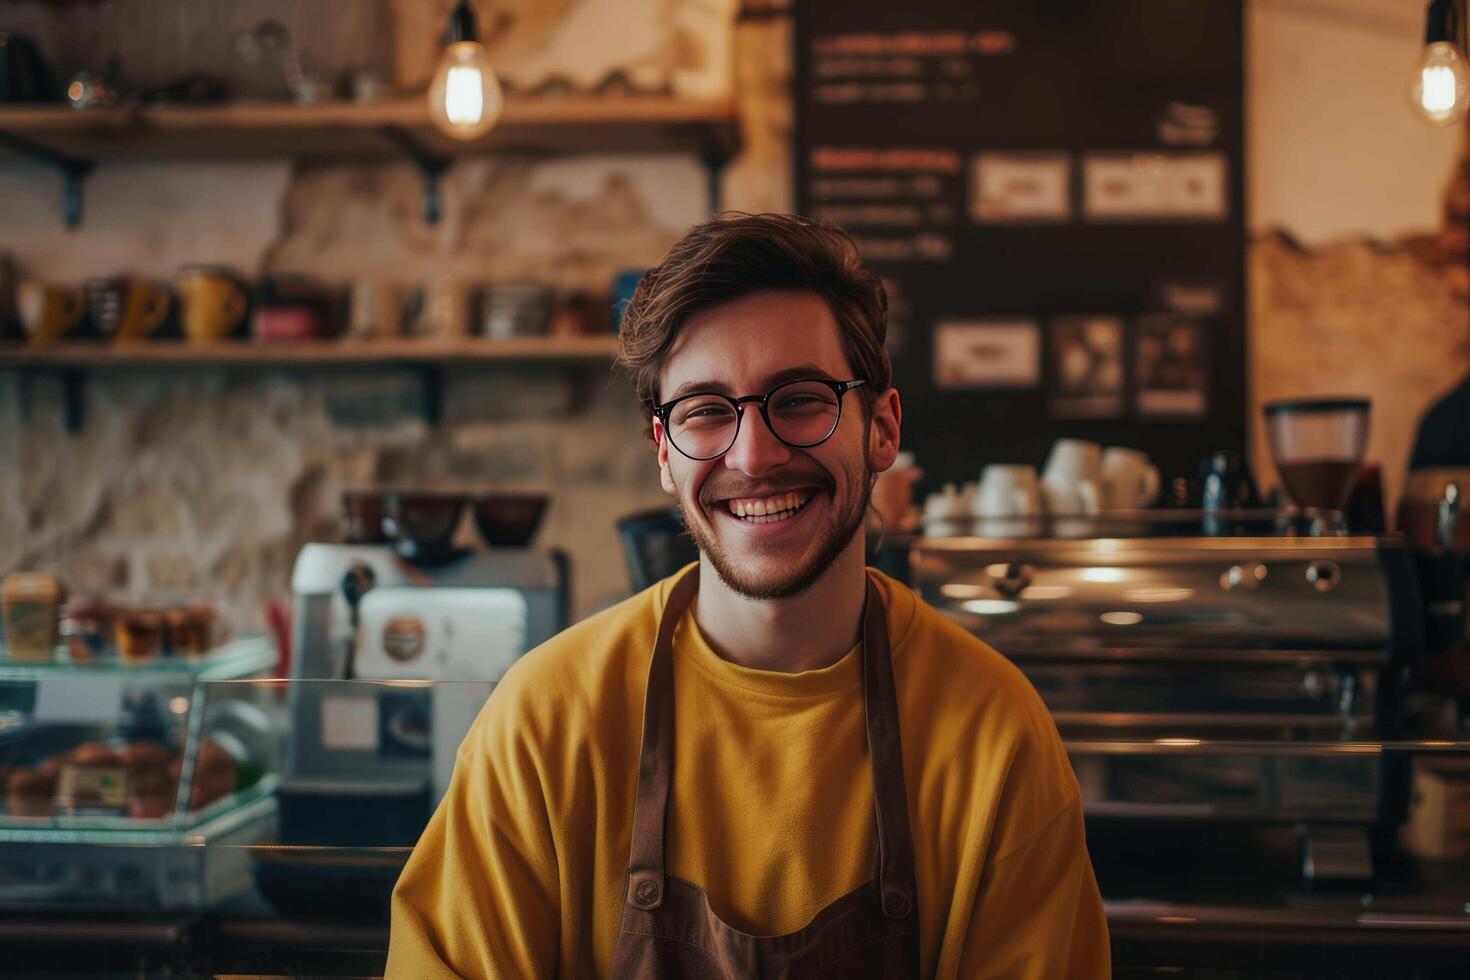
[0,96,739,160]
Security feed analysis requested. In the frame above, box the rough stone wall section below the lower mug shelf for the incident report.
[0,367,664,624]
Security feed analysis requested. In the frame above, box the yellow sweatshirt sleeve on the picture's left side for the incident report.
[387,689,560,980]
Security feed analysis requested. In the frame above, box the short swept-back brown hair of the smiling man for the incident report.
[619,212,892,431]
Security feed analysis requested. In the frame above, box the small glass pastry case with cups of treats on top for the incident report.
[0,579,284,908]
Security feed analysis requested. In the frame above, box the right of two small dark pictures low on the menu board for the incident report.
[1133,313,1210,420]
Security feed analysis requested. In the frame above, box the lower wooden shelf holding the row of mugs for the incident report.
[0,335,617,370]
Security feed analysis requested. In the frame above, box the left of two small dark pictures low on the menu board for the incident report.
[1050,316,1126,419]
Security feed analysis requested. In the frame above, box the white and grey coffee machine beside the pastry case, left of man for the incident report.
[270,544,570,887]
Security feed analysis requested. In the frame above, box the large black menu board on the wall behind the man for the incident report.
[794,0,1247,486]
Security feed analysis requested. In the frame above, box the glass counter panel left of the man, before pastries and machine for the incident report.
[0,669,494,921]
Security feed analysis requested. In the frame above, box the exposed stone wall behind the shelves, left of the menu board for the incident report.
[0,0,758,626]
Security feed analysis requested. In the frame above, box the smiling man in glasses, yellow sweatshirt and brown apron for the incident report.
[388,215,1108,980]
